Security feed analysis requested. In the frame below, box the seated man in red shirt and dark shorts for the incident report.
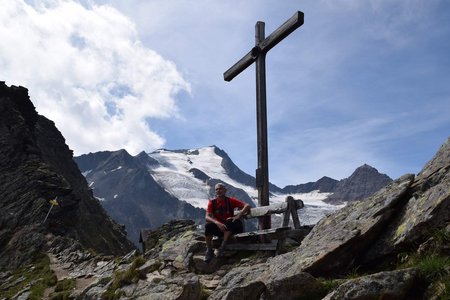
[205,183,250,262]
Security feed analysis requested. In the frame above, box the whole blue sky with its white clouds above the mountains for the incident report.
[0,0,450,187]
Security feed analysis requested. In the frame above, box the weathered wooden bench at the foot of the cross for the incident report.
[218,196,311,253]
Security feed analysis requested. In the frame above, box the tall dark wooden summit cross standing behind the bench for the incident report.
[223,11,304,229]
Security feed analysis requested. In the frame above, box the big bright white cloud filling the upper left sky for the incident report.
[0,0,190,154]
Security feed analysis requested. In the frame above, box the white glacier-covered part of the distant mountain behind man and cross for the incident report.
[148,146,341,224]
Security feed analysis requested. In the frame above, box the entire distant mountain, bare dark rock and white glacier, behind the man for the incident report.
[75,146,385,243]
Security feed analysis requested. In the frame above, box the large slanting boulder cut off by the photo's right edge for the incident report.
[363,138,450,265]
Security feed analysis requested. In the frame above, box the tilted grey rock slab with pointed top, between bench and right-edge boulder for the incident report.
[291,174,414,276]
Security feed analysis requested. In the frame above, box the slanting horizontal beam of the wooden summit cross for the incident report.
[223,11,304,81]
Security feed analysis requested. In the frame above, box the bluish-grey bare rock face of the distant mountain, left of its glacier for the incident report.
[75,150,205,245]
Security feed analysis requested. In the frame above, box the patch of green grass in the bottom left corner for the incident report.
[0,253,57,300]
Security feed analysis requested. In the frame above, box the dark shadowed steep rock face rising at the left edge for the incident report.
[0,82,133,268]
